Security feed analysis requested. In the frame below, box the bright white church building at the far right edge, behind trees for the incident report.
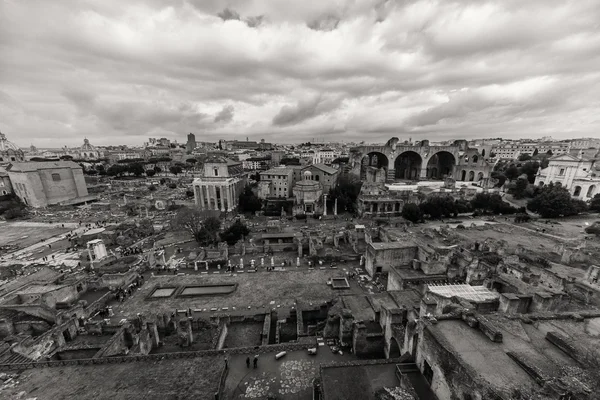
[535,154,600,200]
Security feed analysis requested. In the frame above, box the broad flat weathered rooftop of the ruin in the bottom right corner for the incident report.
[427,314,600,398]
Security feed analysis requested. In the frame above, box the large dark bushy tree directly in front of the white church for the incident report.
[527,183,585,218]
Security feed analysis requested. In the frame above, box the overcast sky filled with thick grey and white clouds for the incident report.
[0,0,600,147]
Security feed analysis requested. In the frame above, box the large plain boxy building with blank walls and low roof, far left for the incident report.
[7,161,88,208]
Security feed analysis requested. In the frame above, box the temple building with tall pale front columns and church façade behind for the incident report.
[193,155,246,212]
